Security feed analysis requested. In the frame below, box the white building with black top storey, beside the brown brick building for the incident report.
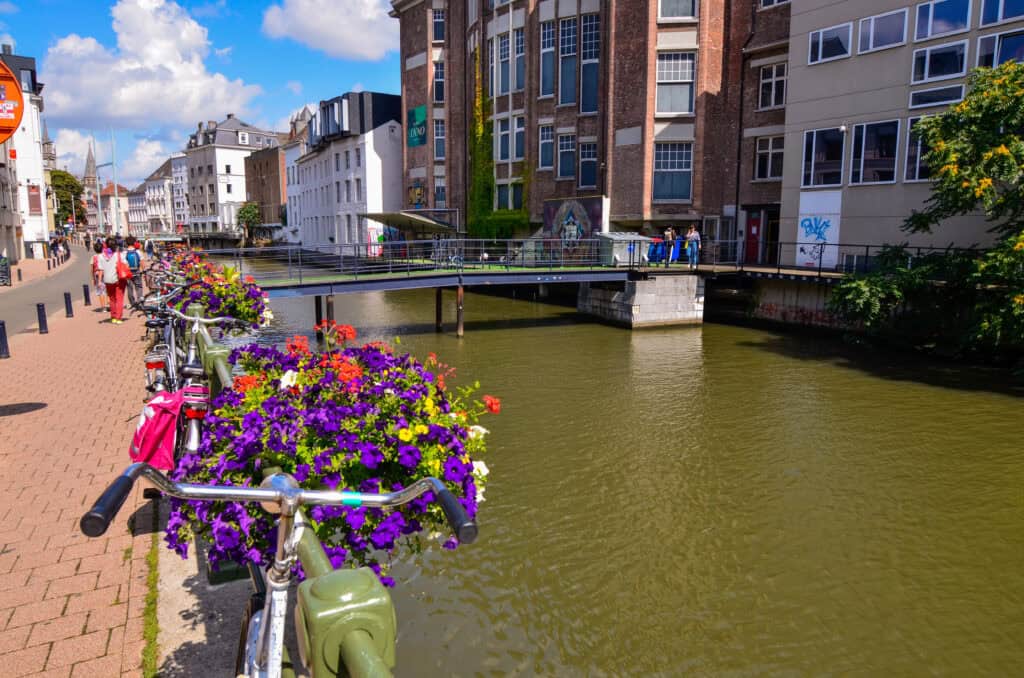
[289,92,402,247]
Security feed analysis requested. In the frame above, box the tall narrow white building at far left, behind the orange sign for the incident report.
[0,45,50,259]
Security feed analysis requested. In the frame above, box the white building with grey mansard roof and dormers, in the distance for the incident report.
[185,113,278,234]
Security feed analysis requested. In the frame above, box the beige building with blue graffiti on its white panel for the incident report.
[774,0,1024,268]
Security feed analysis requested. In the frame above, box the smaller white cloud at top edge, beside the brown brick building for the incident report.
[263,0,398,60]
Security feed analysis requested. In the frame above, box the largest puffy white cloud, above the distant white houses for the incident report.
[40,0,261,129]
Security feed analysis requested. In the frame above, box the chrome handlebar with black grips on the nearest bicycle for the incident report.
[79,462,478,544]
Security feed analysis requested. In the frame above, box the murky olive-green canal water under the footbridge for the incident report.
[249,291,1024,676]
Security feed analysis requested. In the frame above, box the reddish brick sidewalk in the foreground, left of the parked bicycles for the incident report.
[0,303,152,678]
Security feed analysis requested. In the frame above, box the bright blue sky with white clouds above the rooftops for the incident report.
[0,0,400,184]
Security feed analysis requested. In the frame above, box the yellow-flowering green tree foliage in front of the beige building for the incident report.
[904,61,1024,236]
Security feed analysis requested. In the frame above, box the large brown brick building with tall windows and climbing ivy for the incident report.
[392,0,750,237]
